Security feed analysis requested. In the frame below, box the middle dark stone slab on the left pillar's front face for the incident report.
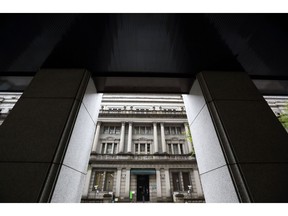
[0,98,78,162]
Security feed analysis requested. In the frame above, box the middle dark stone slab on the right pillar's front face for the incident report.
[214,101,288,163]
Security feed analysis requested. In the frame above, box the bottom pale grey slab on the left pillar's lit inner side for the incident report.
[51,165,85,203]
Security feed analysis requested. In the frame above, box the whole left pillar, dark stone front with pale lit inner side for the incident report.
[0,70,101,202]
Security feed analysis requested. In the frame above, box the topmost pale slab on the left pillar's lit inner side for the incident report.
[82,78,103,124]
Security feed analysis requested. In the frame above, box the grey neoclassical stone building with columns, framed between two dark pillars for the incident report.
[82,94,204,202]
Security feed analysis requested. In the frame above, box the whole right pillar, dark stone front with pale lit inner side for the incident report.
[184,72,288,202]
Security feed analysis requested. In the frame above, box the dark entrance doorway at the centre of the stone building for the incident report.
[137,175,149,202]
